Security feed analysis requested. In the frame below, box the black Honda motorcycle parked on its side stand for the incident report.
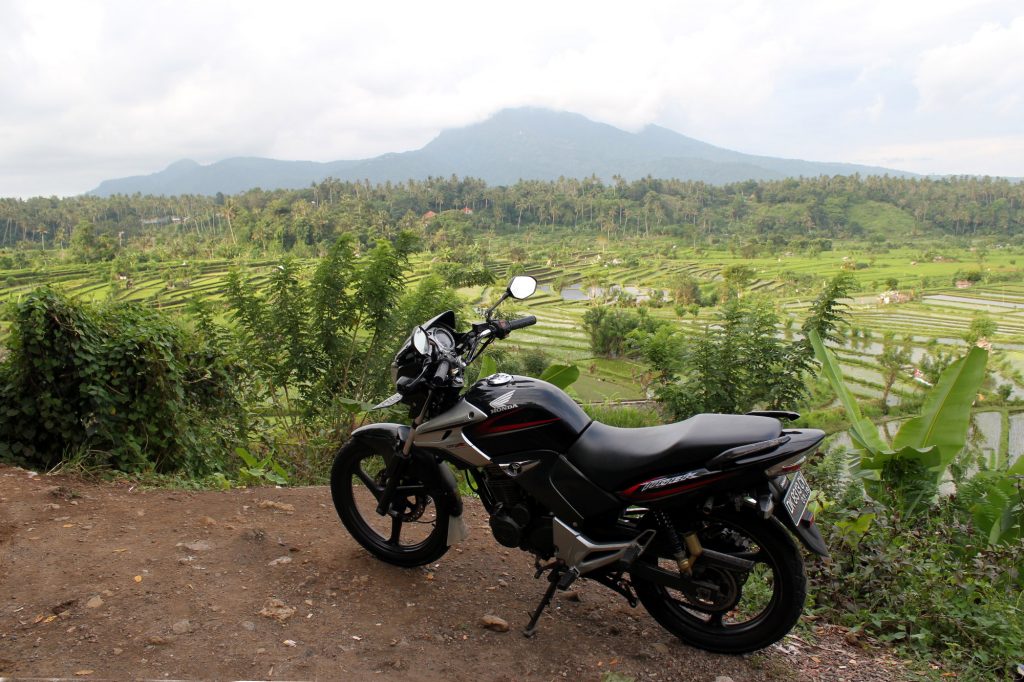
[331,276,827,653]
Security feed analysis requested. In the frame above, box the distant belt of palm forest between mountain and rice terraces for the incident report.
[6,176,1024,253]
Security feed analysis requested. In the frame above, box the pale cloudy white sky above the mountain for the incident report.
[0,0,1024,198]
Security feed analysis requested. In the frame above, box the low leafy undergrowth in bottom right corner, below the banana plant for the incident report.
[809,502,1024,679]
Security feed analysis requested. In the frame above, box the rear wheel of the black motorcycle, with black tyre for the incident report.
[631,514,807,653]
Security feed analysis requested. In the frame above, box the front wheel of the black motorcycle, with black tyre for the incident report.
[331,440,449,567]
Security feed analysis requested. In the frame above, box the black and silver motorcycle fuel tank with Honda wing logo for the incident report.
[464,374,591,458]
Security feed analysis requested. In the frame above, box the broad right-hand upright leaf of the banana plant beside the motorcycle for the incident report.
[893,347,988,466]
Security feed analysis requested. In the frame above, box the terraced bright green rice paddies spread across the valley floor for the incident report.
[6,239,1024,411]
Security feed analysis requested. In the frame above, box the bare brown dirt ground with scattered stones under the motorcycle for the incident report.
[0,466,903,682]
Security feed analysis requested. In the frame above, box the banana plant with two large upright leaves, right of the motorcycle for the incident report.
[808,331,988,516]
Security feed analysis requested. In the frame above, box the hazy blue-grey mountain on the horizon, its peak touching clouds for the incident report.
[89,109,911,197]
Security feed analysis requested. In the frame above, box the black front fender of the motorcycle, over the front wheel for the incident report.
[351,424,465,545]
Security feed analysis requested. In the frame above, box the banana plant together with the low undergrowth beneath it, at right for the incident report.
[811,333,1024,675]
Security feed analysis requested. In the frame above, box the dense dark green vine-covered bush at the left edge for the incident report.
[0,289,242,474]
